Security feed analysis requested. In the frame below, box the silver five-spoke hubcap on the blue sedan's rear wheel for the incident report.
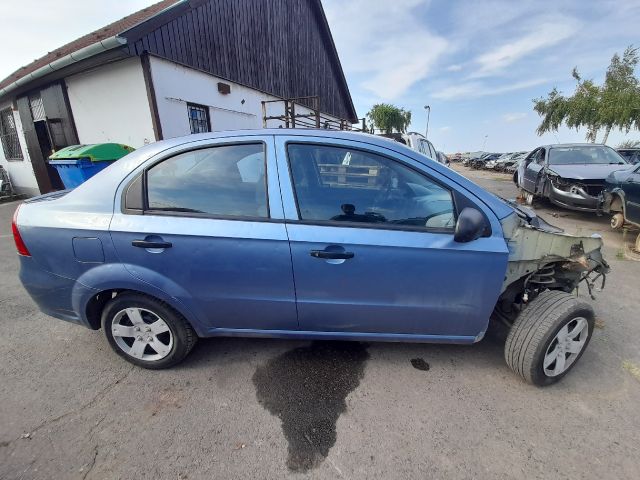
[111,308,173,362]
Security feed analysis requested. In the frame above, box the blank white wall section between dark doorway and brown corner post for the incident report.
[65,57,155,148]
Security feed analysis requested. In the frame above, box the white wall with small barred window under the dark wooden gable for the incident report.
[150,57,344,138]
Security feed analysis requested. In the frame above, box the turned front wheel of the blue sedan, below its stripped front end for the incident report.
[504,290,595,386]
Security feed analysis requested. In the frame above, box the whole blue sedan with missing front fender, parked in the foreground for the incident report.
[13,129,608,385]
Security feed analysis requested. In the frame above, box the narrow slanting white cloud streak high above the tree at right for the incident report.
[472,18,578,77]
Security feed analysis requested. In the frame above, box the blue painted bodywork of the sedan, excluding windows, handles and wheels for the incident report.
[18,130,513,343]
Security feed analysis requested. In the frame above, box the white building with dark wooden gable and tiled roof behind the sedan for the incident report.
[0,0,357,195]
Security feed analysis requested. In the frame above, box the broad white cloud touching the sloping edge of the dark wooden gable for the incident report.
[323,0,448,100]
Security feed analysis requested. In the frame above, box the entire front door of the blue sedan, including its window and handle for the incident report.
[276,137,507,342]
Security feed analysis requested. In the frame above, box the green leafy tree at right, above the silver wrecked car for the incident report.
[533,46,640,143]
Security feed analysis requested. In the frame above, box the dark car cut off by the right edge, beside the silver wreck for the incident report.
[600,165,640,230]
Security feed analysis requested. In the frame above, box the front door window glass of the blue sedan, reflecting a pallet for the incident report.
[288,144,455,230]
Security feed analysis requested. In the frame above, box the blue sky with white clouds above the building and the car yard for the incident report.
[0,0,640,152]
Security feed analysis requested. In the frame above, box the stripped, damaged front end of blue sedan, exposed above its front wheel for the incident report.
[494,202,609,323]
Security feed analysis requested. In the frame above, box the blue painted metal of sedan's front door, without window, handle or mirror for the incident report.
[276,137,508,338]
